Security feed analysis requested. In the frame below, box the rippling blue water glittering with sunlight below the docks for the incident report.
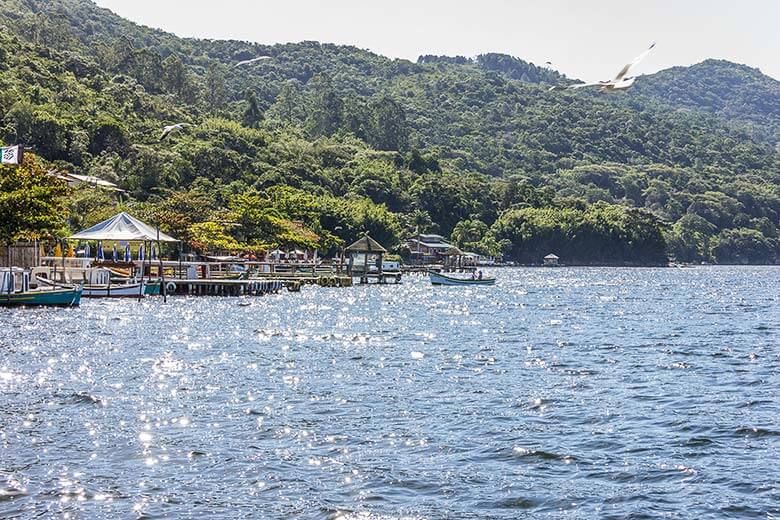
[0,267,780,519]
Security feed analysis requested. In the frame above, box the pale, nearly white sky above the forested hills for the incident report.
[95,0,780,81]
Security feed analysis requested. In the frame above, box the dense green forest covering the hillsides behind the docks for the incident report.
[0,0,780,265]
